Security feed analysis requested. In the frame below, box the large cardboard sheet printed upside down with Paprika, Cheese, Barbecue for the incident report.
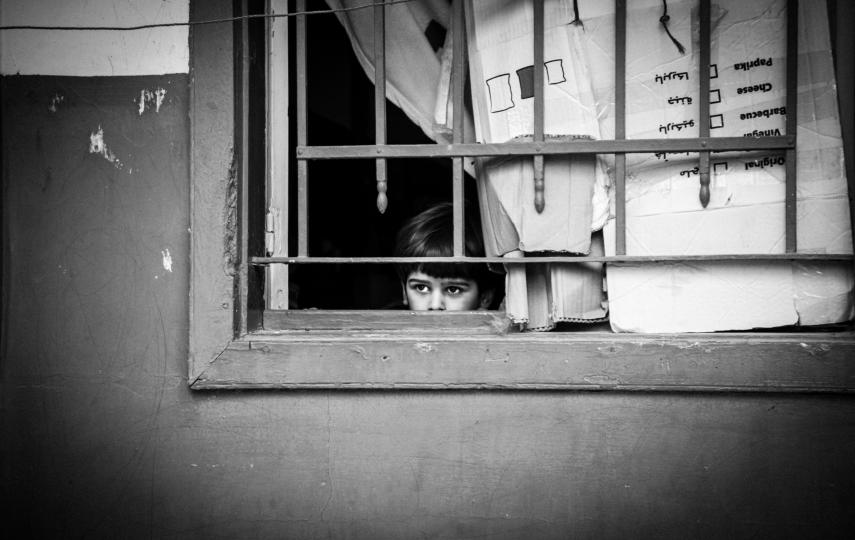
[600,0,855,332]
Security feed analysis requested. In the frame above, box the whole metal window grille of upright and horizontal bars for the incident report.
[262,0,853,265]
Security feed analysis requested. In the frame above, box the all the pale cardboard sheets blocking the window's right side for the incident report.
[467,0,853,332]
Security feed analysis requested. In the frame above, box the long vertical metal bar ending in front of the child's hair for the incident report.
[451,0,466,257]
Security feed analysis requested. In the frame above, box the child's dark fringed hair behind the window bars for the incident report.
[395,203,501,296]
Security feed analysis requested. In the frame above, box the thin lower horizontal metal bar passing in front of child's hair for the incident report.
[251,253,853,266]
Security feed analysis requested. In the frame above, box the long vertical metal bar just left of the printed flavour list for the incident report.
[615,0,626,255]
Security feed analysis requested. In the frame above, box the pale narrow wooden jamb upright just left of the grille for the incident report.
[265,0,289,309]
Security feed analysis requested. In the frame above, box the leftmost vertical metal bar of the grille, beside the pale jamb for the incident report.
[296,0,309,257]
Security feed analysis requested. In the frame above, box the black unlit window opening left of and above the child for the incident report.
[268,9,488,309]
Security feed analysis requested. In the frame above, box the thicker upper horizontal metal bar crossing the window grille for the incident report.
[297,136,795,160]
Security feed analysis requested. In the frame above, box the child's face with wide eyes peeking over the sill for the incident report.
[404,272,489,311]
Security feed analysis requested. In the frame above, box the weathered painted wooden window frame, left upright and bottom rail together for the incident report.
[188,0,855,393]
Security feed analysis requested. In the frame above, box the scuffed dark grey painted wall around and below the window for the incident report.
[5,0,855,539]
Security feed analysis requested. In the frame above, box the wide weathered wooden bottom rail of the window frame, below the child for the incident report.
[191,320,855,393]
